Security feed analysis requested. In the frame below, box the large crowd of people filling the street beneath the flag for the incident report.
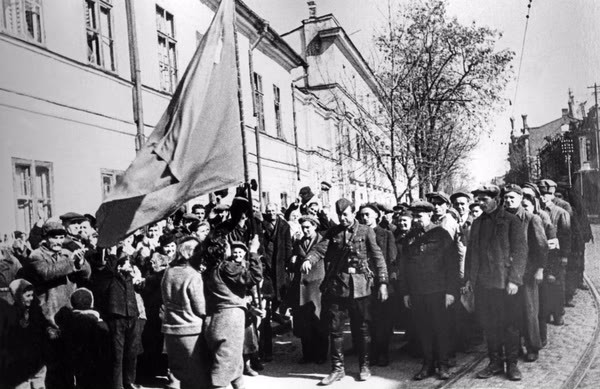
[0,179,593,389]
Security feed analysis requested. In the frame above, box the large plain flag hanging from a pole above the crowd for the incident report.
[96,0,244,247]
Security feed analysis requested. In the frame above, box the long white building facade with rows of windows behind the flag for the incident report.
[0,0,393,236]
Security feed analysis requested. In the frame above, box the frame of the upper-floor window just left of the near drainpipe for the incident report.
[83,0,117,73]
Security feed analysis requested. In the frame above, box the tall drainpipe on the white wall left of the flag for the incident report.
[125,0,146,152]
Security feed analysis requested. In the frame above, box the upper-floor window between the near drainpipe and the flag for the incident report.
[156,5,177,93]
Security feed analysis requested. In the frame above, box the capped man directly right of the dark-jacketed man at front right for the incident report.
[503,184,548,362]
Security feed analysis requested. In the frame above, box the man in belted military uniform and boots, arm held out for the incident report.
[302,198,388,385]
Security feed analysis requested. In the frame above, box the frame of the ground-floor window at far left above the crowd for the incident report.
[11,157,55,232]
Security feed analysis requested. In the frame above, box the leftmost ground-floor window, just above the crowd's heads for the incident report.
[13,158,53,231]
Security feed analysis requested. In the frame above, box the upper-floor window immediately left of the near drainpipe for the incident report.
[85,0,116,71]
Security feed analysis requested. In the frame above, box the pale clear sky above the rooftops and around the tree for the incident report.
[245,0,600,183]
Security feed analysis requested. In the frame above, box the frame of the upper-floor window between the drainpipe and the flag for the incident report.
[155,4,179,94]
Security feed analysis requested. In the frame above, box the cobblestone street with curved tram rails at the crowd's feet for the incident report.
[246,226,600,389]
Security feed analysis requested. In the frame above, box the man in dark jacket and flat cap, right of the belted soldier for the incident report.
[399,201,459,381]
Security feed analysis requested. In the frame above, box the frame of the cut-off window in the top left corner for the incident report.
[0,0,46,46]
